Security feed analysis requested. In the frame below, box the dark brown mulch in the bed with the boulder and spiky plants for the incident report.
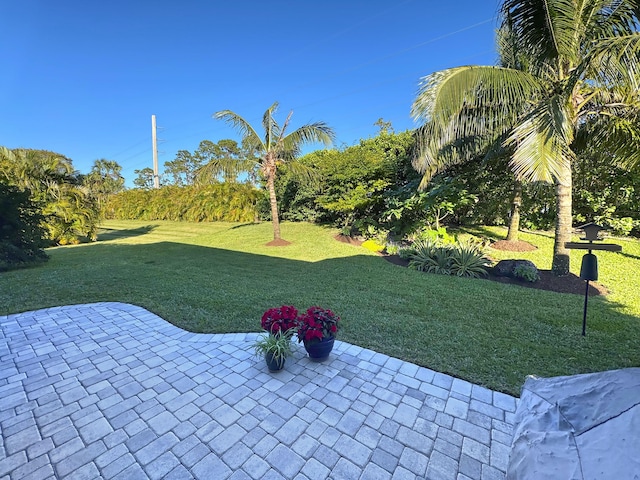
[384,255,609,296]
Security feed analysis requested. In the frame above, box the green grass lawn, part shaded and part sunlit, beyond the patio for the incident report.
[0,221,640,395]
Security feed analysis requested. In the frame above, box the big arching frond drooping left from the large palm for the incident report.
[412,66,543,189]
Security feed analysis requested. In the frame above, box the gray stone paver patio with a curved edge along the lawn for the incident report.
[0,303,517,480]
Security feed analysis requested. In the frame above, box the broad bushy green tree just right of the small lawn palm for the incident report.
[278,129,421,234]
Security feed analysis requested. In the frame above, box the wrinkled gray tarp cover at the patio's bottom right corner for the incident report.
[507,368,640,480]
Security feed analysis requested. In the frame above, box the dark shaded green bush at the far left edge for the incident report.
[0,183,48,271]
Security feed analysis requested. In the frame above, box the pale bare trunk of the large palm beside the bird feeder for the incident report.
[551,161,572,276]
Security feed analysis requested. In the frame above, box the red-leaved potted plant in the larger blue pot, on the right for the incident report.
[298,306,340,362]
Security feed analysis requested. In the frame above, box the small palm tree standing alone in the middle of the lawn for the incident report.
[208,102,334,240]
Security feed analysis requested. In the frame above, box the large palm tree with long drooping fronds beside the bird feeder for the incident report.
[412,0,640,275]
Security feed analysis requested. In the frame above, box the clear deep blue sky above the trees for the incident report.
[0,0,499,186]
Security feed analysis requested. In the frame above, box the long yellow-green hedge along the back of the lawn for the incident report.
[104,183,263,222]
